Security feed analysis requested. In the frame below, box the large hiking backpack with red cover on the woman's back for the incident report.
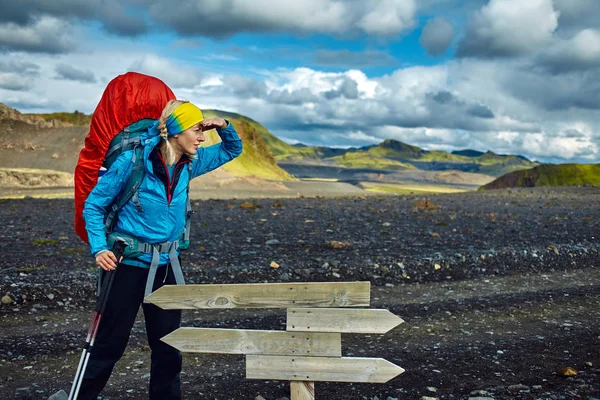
[74,72,175,243]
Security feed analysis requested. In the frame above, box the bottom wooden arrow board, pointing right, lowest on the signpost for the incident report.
[246,355,404,383]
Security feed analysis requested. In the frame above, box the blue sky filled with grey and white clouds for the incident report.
[0,0,600,163]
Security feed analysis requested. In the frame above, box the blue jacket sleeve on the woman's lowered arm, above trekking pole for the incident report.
[83,151,133,256]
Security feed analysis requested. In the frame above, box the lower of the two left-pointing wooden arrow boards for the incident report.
[161,328,342,357]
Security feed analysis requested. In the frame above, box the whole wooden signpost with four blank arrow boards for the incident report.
[144,282,404,400]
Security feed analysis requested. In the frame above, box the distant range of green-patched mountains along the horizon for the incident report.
[263,137,539,176]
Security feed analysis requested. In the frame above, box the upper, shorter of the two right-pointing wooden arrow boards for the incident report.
[286,308,404,334]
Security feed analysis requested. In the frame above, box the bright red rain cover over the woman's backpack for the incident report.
[75,72,175,243]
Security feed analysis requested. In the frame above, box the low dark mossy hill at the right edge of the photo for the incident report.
[480,164,600,190]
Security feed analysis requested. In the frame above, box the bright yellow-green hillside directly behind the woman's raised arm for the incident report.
[203,110,295,180]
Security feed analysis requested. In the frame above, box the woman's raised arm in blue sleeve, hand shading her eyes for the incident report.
[192,118,242,178]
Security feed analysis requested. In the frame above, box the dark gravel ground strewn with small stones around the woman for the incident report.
[0,188,600,400]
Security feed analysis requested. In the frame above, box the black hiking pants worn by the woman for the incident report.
[78,264,181,400]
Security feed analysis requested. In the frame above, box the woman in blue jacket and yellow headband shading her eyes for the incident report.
[78,100,242,400]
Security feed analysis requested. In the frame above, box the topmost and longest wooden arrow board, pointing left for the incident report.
[144,282,371,310]
